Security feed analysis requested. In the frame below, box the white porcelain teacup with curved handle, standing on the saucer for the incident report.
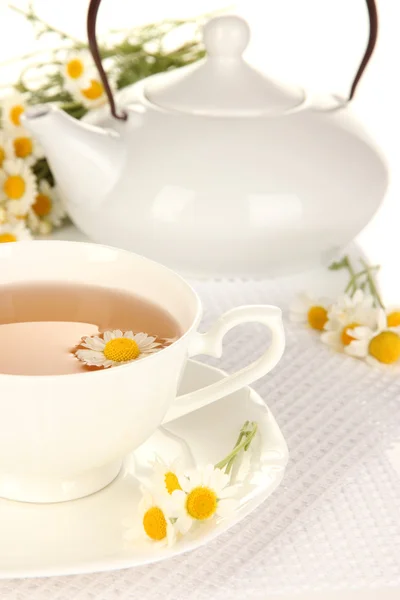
[0,241,285,502]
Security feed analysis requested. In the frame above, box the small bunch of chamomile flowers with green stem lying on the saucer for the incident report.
[123,421,257,546]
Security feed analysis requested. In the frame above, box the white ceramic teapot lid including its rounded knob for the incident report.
[144,15,305,116]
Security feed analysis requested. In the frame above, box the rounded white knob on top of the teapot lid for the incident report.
[203,15,250,58]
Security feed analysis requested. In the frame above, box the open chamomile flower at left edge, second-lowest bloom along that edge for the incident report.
[0,158,36,217]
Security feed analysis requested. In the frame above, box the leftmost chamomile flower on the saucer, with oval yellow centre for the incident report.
[123,488,176,546]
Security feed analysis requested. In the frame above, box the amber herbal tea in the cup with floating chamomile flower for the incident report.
[0,283,180,375]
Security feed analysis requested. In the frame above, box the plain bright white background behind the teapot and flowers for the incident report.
[0,0,400,600]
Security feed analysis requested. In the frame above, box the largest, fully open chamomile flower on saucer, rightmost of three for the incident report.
[171,465,238,534]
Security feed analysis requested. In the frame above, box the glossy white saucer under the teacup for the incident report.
[0,361,288,578]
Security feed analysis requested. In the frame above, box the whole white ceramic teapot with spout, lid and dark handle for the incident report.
[24,0,388,277]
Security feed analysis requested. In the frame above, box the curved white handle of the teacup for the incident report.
[163,305,285,425]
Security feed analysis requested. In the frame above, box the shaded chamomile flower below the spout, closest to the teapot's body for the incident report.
[28,179,66,234]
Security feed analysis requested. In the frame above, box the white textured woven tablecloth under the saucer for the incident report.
[0,274,400,600]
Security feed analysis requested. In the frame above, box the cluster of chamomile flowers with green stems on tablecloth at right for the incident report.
[290,257,400,367]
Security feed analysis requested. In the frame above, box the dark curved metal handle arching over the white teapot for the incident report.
[87,0,378,121]
